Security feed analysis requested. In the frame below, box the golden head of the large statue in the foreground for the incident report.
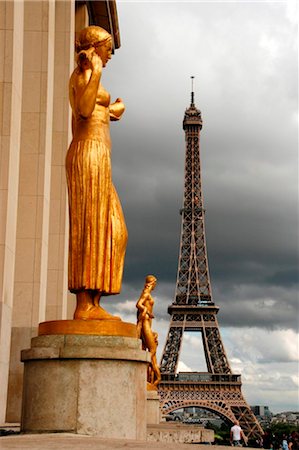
[76,25,112,67]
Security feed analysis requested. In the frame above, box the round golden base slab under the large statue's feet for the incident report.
[38,320,137,338]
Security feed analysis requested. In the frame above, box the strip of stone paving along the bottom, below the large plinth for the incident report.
[0,433,251,450]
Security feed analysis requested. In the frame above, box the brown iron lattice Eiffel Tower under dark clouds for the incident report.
[159,77,263,440]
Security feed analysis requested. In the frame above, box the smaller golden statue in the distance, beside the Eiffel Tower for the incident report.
[136,275,161,390]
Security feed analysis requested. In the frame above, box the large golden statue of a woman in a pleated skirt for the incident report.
[66,26,128,319]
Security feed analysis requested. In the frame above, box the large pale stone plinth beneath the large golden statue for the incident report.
[21,334,150,440]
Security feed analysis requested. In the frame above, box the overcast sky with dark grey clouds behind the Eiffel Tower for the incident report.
[103,0,299,412]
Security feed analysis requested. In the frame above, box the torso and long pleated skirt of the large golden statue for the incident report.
[66,85,127,295]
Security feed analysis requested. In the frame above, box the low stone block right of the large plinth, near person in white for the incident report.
[147,422,214,444]
